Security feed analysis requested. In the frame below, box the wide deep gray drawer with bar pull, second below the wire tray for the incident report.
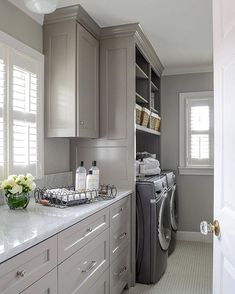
[58,230,109,294]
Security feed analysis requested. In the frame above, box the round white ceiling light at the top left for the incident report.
[24,0,58,14]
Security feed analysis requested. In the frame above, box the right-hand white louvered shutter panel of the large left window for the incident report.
[9,50,43,177]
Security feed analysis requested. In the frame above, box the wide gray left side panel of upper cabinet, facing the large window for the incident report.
[44,21,76,137]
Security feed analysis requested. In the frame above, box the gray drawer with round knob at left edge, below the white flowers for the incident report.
[0,236,57,294]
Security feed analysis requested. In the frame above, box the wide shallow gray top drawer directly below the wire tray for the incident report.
[58,208,109,263]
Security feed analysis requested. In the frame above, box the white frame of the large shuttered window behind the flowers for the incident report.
[0,31,44,180]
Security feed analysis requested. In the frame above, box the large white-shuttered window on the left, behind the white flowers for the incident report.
[0,32,44,179]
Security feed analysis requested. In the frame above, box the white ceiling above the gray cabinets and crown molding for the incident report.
[10,0,213,74]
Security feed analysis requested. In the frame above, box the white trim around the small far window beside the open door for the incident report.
[179,91,214,175]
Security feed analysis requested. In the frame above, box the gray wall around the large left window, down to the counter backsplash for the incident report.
[0,0,70,174]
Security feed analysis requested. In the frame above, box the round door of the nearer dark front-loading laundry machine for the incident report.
[158,190,171,251]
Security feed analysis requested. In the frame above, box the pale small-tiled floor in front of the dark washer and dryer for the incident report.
[125,242,212,294]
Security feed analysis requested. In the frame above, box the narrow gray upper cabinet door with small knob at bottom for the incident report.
[77,24,99,138]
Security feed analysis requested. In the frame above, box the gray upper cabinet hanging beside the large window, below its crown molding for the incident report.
[44,11,99,138]
